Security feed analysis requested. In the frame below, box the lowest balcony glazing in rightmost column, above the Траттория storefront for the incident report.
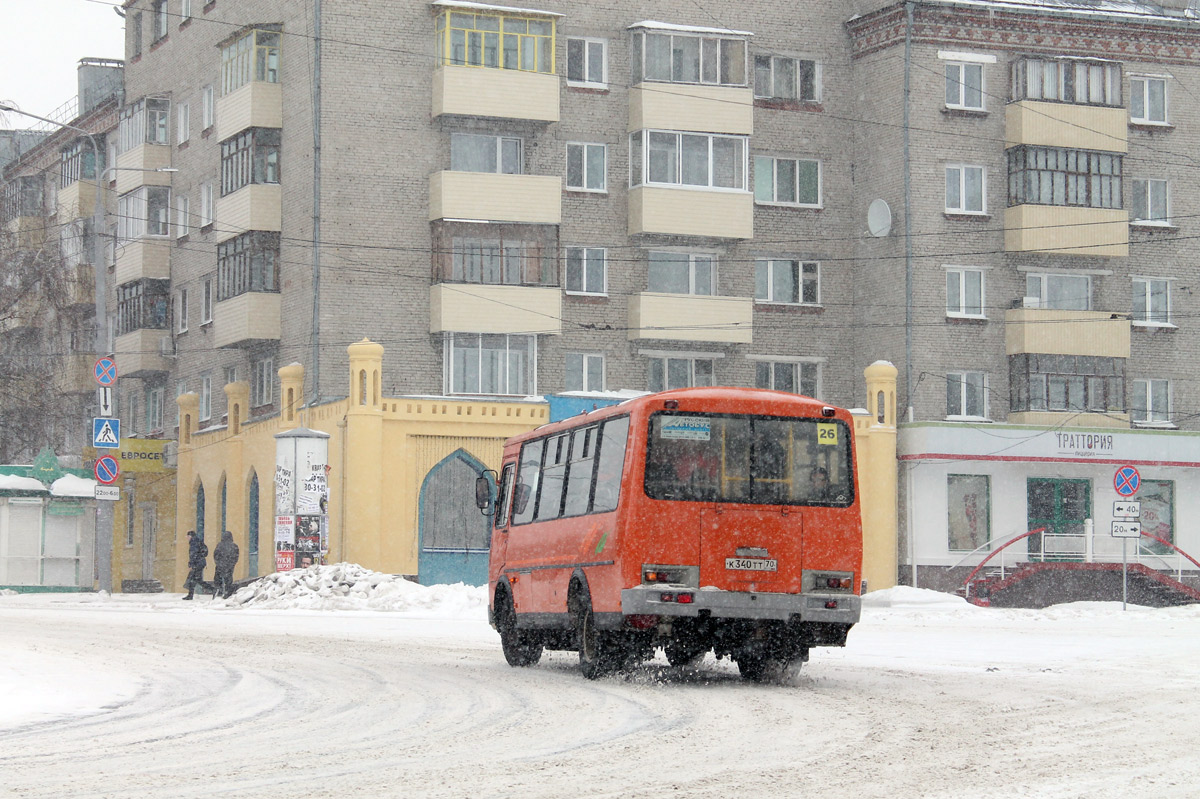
[1008,354,1126,413]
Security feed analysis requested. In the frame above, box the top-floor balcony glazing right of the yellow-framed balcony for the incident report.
[632,30,746,86]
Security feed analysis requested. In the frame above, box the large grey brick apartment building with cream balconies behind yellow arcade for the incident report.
[96,0,1200,585]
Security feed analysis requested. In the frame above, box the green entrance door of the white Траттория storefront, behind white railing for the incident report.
[1026,477,1092,560]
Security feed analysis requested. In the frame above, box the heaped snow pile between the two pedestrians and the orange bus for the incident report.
[224,563,487,618]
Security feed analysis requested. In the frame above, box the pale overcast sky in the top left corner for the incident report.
[0,0,125,127]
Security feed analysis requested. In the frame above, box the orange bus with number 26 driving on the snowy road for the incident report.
[476,388,863,680]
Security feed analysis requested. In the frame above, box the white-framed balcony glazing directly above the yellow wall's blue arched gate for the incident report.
[446,334,538,395]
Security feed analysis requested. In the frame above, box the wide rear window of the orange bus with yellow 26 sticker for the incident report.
[646,413,854,507]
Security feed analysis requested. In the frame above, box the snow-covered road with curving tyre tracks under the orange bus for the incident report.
[0,578,1200,799]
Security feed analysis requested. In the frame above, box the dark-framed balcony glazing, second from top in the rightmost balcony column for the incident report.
[1008,146,1123,208]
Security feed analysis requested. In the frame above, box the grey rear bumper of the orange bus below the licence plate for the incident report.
[620,585,863,624]
